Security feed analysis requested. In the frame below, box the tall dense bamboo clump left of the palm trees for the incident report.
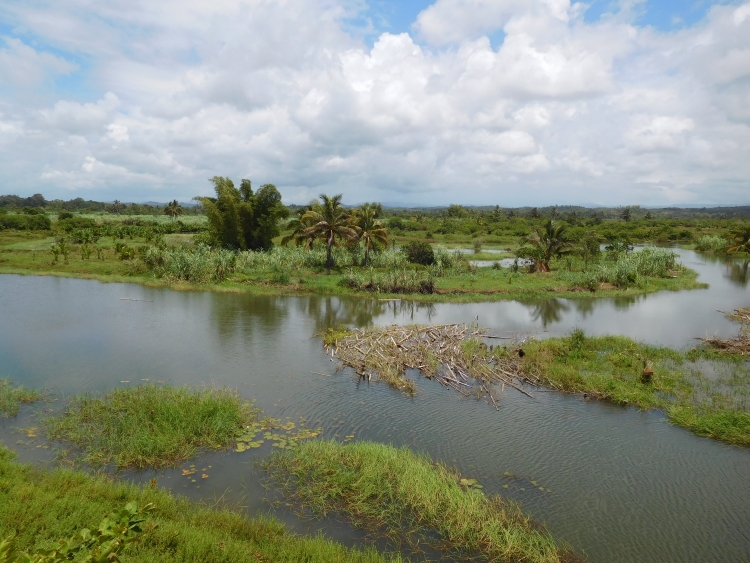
[195,176,289,250]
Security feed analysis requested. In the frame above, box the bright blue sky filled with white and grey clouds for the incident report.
[0,0,750,207]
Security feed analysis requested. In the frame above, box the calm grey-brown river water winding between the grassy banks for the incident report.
[0,252,750,563]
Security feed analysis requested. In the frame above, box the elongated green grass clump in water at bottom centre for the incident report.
[267,441,580,562]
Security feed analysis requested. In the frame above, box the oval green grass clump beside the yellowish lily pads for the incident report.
[45,385,258,469]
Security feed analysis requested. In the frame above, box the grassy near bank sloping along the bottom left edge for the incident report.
[0,445,401,563]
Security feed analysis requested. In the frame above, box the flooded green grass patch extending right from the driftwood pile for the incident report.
[522,329,750,446]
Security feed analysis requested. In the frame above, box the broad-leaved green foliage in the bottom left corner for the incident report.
[0,501,154,563]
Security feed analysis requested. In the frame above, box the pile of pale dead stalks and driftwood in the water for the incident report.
[330,324,533,408]
